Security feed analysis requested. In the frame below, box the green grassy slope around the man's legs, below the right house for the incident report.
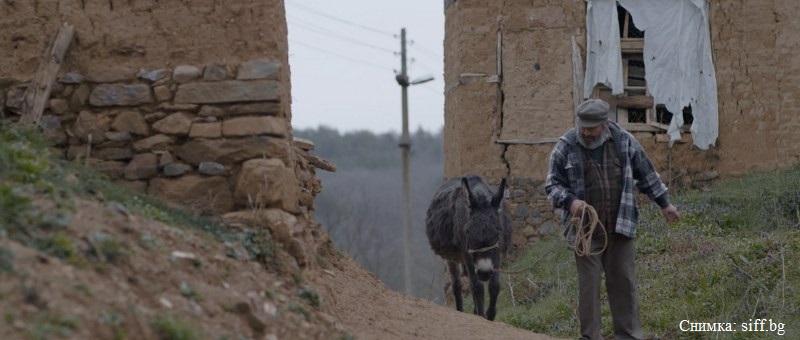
[498,165,800,338]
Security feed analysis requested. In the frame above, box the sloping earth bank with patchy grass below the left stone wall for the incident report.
[0,127,344,339]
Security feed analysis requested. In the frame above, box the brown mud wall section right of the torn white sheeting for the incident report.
[710,0,800,173]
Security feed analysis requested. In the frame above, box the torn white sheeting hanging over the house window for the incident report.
[584,0,719,150]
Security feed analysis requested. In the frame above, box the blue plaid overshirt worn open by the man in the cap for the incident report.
[545,122,669,238]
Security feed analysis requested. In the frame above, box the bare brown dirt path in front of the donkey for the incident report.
[316,259,551,340]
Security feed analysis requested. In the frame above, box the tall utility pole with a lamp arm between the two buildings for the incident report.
[394,28,433,295]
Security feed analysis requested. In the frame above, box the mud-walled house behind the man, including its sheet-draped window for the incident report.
[444,0,800,243]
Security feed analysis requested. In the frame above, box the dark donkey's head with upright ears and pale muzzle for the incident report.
[461,178,507,281]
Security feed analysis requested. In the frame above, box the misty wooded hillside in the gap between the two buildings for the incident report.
[294,127,444,302]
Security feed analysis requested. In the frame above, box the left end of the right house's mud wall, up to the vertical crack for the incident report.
[444,1,507,179]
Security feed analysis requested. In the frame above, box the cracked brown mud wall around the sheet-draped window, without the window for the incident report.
[445,0,800,242]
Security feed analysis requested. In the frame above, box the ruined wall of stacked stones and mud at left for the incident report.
[0,0,332,266]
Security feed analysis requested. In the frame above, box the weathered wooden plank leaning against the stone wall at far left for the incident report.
[20,23,75,124]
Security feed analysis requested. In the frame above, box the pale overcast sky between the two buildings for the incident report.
[285,0,444,133]
